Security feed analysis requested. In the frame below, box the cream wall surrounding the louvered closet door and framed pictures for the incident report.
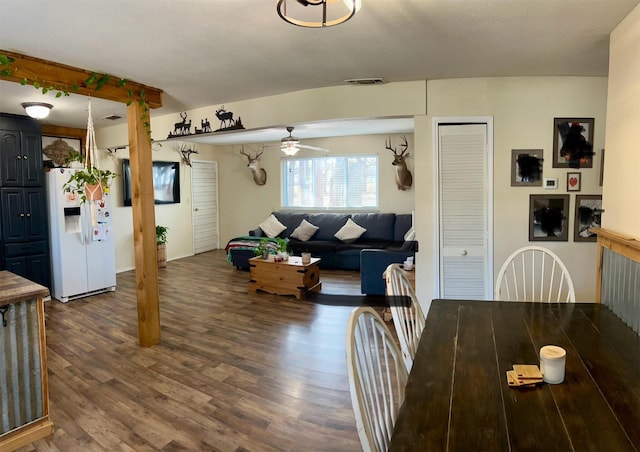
[414,77,607,301]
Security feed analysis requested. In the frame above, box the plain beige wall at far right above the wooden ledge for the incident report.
[602,6,640,239]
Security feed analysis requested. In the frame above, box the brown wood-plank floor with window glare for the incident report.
[22,251,368,451]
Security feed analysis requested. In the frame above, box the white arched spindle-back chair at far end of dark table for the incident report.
[494,246,576,303]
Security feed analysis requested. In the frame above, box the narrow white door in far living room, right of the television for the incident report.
[191,160,220,254]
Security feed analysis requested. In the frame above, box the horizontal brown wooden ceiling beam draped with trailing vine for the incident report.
[0,49,162,108]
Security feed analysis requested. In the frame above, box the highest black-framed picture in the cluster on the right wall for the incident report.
[553,118,594,168]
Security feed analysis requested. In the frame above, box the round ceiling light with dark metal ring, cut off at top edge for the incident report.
[277,0,361,28]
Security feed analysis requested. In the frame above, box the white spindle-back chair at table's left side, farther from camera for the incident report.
[384,264,425,371]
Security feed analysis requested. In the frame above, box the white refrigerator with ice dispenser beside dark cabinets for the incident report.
[45,168,116,303]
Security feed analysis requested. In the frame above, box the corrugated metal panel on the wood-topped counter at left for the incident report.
[0,299,44,434]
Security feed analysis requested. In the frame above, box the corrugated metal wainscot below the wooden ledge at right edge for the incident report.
[600,248,640,334]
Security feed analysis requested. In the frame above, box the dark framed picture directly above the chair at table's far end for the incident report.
[529,195,569,242]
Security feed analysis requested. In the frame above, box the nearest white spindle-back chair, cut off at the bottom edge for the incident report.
[346,306,408,451]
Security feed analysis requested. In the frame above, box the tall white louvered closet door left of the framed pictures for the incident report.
[438,124,491,300]
